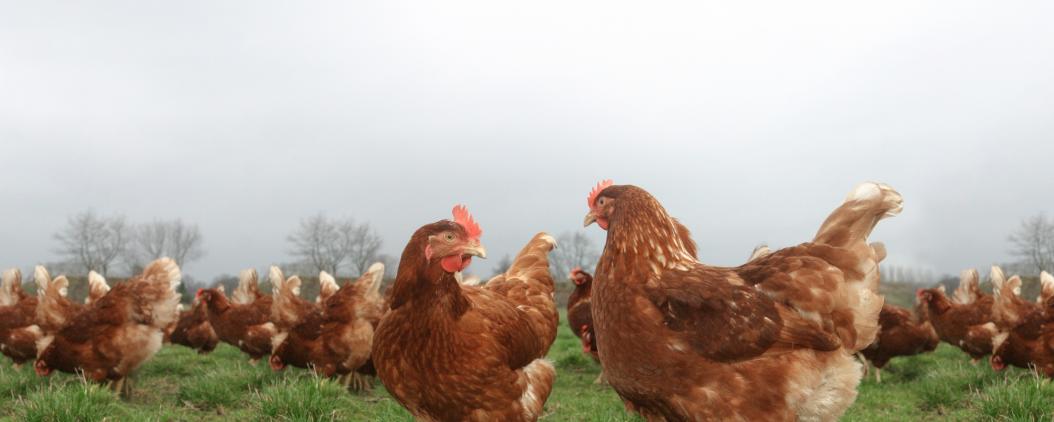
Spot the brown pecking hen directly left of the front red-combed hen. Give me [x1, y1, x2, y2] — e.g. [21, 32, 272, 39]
[270, 263, 385, 388]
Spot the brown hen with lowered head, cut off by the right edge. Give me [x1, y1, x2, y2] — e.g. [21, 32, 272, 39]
[990, 267, 1054, 378]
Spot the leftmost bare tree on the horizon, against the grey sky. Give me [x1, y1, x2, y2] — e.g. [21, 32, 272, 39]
[54, 211, 130, 275]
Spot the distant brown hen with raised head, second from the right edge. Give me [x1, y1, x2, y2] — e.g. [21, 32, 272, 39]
[915, 271, 996, 362]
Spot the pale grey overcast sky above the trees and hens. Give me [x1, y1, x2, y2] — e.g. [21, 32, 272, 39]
[0, 0, 1054, 280]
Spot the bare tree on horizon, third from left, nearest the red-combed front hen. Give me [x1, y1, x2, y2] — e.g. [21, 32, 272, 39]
[287, 213, 382, 276]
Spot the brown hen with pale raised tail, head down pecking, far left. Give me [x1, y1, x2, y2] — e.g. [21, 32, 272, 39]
[34, 258, 181, 392]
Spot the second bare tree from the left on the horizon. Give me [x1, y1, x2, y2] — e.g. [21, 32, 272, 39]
[124, 219, 204, 273]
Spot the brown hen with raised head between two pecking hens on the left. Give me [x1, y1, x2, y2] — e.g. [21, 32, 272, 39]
[195, 271, 276, 364]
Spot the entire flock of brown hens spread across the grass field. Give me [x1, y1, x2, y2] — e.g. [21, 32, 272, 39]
[0, 180, 1054, 421]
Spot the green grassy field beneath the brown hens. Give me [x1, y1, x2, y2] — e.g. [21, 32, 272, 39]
[0, 318, 1054, 421]
